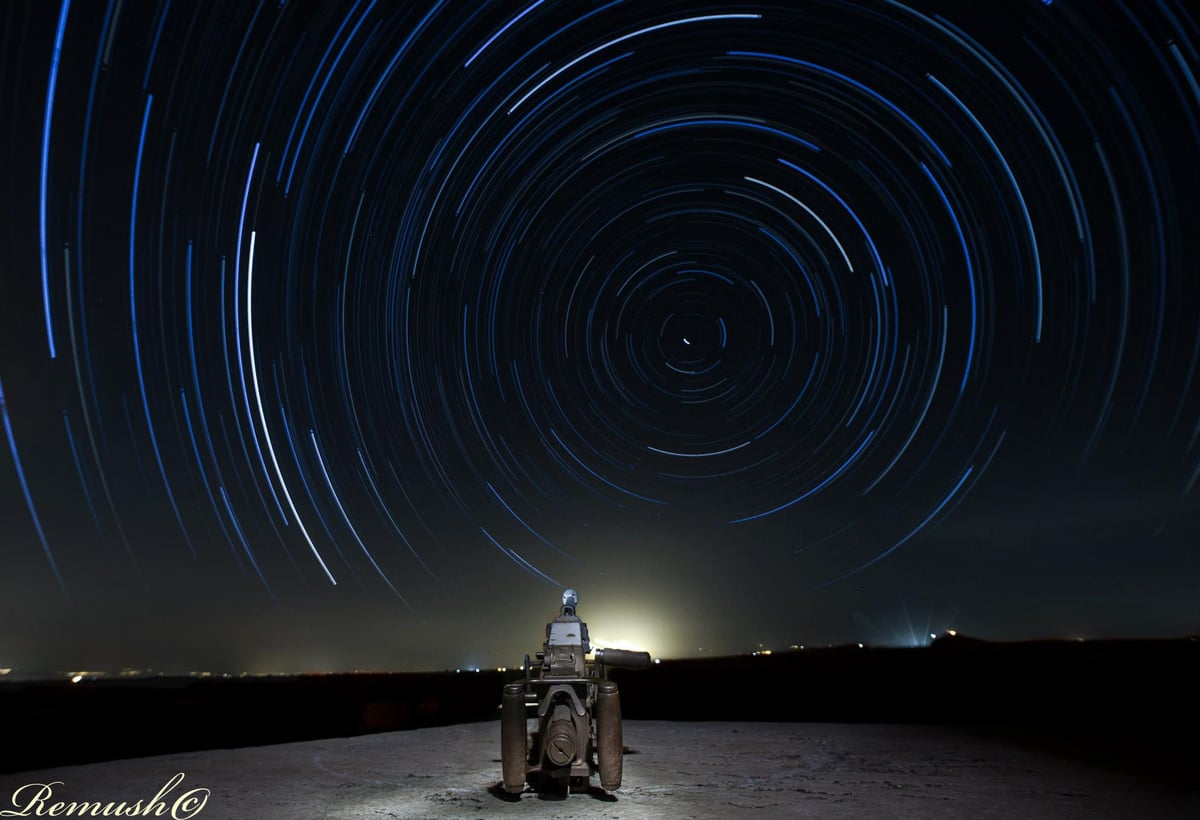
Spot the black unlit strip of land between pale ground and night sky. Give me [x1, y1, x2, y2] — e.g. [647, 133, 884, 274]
[0, 636, 1200, 785]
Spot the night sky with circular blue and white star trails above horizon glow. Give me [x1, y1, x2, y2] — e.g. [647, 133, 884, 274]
[0, 0, 1200, 676]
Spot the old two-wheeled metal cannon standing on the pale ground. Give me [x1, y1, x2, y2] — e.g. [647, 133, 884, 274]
[500, 589, 650, 795]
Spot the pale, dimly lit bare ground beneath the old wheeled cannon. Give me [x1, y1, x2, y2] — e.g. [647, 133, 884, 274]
[0, 720, 1200, 820]
